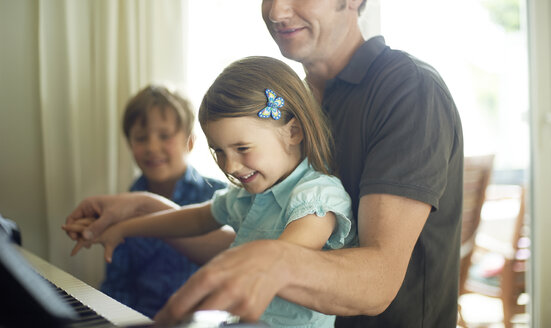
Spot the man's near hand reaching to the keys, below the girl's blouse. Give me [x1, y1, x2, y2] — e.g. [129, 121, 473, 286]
[155, 240, 291, 326]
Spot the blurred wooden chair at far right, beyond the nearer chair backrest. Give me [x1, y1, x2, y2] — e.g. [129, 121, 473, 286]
[461, 185, 530, 328]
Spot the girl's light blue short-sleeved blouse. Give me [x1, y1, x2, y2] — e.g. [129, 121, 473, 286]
[212, 159, 357, 327]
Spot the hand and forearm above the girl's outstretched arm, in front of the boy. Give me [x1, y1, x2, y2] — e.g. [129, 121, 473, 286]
[64, 192, 179, 241]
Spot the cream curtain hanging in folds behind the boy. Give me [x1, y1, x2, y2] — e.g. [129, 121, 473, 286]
[39, 0, 186, 286]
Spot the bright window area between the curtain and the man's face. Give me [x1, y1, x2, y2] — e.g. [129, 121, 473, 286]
[184, 0, 304, 180]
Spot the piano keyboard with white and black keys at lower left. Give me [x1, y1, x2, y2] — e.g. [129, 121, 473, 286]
[18, 247, 153, 328]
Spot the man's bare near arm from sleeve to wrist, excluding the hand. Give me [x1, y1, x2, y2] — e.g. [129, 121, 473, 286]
[278, 194, 431, 315]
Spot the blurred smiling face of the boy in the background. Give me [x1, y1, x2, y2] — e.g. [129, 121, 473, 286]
[128, 108, 192, 183]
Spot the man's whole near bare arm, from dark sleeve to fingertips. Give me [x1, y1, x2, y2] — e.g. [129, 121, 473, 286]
[155, 194, 431, 323]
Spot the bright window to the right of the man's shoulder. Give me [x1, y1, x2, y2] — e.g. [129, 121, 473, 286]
[381, 0, 530, 183]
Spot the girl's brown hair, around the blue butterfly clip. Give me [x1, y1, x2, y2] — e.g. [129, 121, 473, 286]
[199, 56, 334, 174]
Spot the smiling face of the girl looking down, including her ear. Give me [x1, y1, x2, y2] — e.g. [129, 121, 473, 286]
[203, 116, 302, 194]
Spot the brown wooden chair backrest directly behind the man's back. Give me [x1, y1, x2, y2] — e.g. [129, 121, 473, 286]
[459, 154, 494, 294]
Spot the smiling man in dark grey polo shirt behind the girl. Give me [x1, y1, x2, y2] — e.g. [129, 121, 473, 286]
[64, 0, 463, 327]
